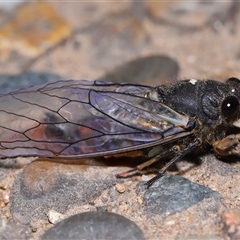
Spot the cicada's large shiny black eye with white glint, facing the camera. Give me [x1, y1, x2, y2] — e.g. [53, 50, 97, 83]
[222, 96, 239, 118]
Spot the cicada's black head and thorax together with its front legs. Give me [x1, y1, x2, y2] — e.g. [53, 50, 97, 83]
[143, 78, 240, 185]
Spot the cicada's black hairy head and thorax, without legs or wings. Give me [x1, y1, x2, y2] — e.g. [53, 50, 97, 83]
[154, 78, 240, 142]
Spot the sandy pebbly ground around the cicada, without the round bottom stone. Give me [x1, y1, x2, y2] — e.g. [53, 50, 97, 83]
[0, 1, 240, 239]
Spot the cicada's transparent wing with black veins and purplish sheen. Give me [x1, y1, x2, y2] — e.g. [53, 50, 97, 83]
[0, 81, 191, 158]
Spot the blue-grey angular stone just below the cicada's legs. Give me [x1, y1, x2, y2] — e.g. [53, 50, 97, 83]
[143, 175, 221, 215]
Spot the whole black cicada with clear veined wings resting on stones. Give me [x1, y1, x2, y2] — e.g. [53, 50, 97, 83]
[0, 78, 240, 186]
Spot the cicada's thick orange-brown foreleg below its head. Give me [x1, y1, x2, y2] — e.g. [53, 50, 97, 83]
[213, 134, 240, 156]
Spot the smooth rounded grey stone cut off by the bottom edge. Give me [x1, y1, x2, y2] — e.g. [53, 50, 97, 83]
[40, 212, 145, 240]
